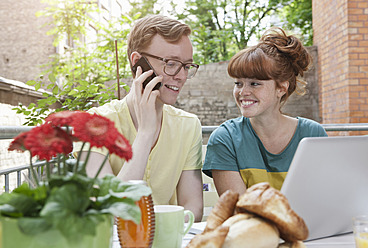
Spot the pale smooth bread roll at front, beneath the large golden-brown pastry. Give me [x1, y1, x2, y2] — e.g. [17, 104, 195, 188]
[222, 213, 280, 248]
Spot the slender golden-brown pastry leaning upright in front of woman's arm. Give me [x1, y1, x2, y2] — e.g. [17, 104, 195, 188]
[204, 190, 239, 232]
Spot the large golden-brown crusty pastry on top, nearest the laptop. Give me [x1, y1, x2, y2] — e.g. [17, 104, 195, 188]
[236, 182, 308, 242]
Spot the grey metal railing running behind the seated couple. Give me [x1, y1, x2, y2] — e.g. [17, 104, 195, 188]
[0, 123, 368, 192]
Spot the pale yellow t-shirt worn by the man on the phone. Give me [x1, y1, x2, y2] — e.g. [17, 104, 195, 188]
[74, 98, 202, 205]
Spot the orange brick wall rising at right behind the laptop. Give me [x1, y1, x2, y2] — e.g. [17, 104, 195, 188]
[313, 0, 368, 126]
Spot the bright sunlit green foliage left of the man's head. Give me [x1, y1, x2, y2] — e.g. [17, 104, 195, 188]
[14, 0, 153, 126]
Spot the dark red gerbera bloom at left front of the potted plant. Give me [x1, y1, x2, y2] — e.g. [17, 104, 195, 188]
[24, 123, 73, 160]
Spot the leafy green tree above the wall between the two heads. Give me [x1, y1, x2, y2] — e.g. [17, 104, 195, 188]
[173, 0, 289, 64]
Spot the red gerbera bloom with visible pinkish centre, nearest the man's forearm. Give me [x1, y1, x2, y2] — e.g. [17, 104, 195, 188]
[73, 114, 118, 147]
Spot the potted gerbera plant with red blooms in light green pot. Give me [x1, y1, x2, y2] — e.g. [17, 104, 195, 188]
[0, 111, 151, 248]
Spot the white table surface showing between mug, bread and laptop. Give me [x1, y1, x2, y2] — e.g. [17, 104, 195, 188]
[112, 222, 355, 248]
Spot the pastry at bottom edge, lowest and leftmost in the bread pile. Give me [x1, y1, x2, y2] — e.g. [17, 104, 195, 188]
[186, 226, 229, 248]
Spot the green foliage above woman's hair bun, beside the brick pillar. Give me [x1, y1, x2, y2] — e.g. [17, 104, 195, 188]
[280, 0, 313, 46]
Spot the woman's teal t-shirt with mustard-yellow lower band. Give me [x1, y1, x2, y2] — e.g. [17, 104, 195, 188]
[203, 117, 327, 189]
